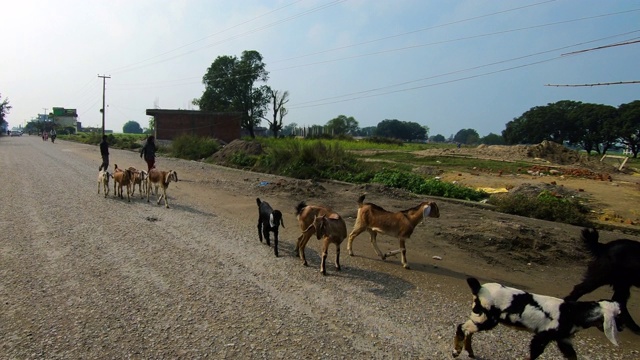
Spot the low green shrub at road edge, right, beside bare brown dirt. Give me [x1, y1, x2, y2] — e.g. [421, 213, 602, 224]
[489, 191, 590, 226]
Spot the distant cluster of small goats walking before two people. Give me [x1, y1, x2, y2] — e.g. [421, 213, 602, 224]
[98, 164, 178, 208]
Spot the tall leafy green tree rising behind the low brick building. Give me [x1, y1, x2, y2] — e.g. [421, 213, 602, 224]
[199, 50, 269, 138]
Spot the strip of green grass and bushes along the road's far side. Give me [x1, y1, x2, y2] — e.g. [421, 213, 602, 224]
[61, 133, 640, 226]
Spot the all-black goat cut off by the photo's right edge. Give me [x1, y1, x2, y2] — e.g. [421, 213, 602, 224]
[564, 228, 640, 335]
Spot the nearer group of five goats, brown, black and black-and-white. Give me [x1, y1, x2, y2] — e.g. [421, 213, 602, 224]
[256, 195, 640, 359]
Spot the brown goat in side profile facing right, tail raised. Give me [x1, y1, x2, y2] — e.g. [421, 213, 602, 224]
[347, 195, 440, 269]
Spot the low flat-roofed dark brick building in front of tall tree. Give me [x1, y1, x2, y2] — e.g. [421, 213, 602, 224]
[147, 109, 242, 143]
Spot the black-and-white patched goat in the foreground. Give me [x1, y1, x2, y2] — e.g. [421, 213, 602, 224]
[453, 278, 620, 360]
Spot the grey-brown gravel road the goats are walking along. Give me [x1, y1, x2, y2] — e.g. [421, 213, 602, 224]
[0, 136, 639, 359]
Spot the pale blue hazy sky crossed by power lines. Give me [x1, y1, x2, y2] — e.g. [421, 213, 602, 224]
[0, 0, 640, 137]
